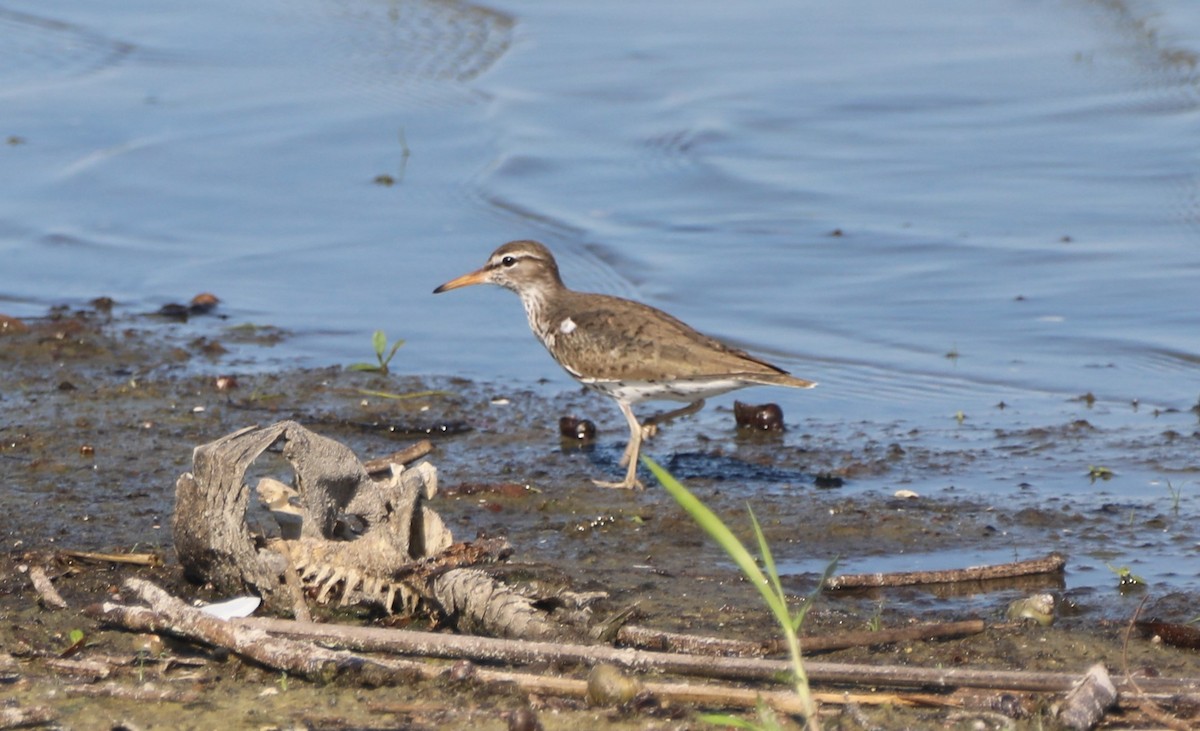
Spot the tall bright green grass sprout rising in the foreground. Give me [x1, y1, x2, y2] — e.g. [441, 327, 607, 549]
[642, 456, 838, 731]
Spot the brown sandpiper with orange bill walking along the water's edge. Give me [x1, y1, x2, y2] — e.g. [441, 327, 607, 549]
[433, 240, 816, 490]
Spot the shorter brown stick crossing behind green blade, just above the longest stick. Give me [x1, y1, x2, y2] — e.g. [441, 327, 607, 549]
[617, 619, 984, 657]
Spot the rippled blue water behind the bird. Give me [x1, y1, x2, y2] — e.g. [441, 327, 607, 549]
[0, 0, 1200, 580]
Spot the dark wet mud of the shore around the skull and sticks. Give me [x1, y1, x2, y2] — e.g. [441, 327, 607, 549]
[0, 301, 1200, 729]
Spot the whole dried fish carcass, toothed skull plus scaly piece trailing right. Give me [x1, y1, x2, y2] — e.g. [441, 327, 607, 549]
[173, 421, 574, 639]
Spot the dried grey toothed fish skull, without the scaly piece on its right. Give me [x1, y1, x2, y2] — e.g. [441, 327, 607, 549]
[173, 421, 451, 611]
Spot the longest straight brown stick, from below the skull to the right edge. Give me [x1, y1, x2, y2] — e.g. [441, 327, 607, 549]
[236, 618, 1200, 702]
